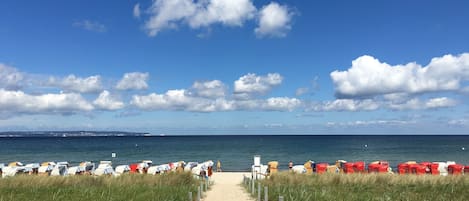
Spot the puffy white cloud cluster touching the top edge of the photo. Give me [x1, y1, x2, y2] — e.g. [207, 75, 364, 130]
[141, 0, 292, 37]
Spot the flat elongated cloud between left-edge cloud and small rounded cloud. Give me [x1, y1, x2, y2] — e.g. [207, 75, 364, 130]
[47, 75, 102, 93]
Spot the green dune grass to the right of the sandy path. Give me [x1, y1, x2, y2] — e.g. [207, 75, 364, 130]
[245, 173, 469, 201]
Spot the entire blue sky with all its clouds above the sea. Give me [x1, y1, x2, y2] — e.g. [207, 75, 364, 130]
[0, 0, 469, 135]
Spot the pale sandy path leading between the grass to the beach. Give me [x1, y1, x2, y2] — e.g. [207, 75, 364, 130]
[203, 172, 253, 201]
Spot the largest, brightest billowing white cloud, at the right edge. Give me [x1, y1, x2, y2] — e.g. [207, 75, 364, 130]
[330, 53, 469, 98]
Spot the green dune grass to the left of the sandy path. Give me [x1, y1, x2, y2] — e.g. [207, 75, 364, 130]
[0, 173, 199, 201]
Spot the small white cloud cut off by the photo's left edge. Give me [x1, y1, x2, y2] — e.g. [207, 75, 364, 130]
[0, 63, 24, 90]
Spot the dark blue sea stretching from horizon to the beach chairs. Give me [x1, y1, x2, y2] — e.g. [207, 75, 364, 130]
[0, 135, 469, 171]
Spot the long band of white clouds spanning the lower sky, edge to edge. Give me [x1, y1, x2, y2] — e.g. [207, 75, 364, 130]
[0, 53, 469, 118]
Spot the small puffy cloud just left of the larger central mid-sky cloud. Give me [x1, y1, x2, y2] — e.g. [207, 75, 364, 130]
[192, 80, 226, 98]
